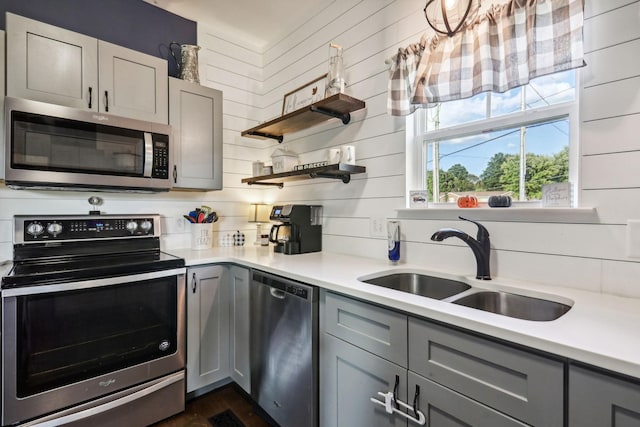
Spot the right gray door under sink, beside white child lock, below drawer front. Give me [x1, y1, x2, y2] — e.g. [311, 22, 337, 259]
[407, 371, 528, 427]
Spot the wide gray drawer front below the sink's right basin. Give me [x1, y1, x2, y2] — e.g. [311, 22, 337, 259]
[409, 317, 565, 427]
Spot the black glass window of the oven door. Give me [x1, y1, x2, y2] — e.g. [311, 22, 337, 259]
[17, 277, 177, 397]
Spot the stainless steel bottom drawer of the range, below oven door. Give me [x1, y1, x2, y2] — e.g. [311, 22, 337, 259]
[22, 371, 185, 427]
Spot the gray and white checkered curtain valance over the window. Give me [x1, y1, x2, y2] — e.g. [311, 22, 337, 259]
[387, 0, 584, 116]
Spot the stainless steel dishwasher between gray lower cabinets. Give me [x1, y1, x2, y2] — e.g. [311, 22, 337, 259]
[250, 271, 318, 427]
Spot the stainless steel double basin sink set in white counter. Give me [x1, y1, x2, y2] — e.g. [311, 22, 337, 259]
[359, 272, 571, 321]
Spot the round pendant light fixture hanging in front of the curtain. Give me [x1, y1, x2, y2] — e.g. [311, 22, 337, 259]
[424, 0, 480, 37]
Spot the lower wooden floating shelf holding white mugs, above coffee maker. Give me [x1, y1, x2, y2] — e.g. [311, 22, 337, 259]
[242, 163, 367, 188]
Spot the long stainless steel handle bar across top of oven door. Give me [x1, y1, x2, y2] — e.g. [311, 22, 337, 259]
[2, 267, 187, 298]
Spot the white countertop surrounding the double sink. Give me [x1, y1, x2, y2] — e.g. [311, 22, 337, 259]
[168, 246, 640, 378]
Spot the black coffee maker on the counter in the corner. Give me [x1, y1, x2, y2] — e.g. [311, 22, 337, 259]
[269, 205, 322, 255]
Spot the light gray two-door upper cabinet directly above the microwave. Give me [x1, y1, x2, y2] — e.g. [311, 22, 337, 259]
[7, 13, 168, 124]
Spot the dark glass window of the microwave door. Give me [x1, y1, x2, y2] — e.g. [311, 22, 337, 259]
[12, 115, 144, 176]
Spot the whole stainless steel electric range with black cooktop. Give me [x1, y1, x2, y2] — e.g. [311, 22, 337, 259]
[1, 215, 186, 427]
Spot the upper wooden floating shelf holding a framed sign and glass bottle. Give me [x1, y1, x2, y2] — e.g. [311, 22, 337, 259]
[242, 93, 365, 142]
